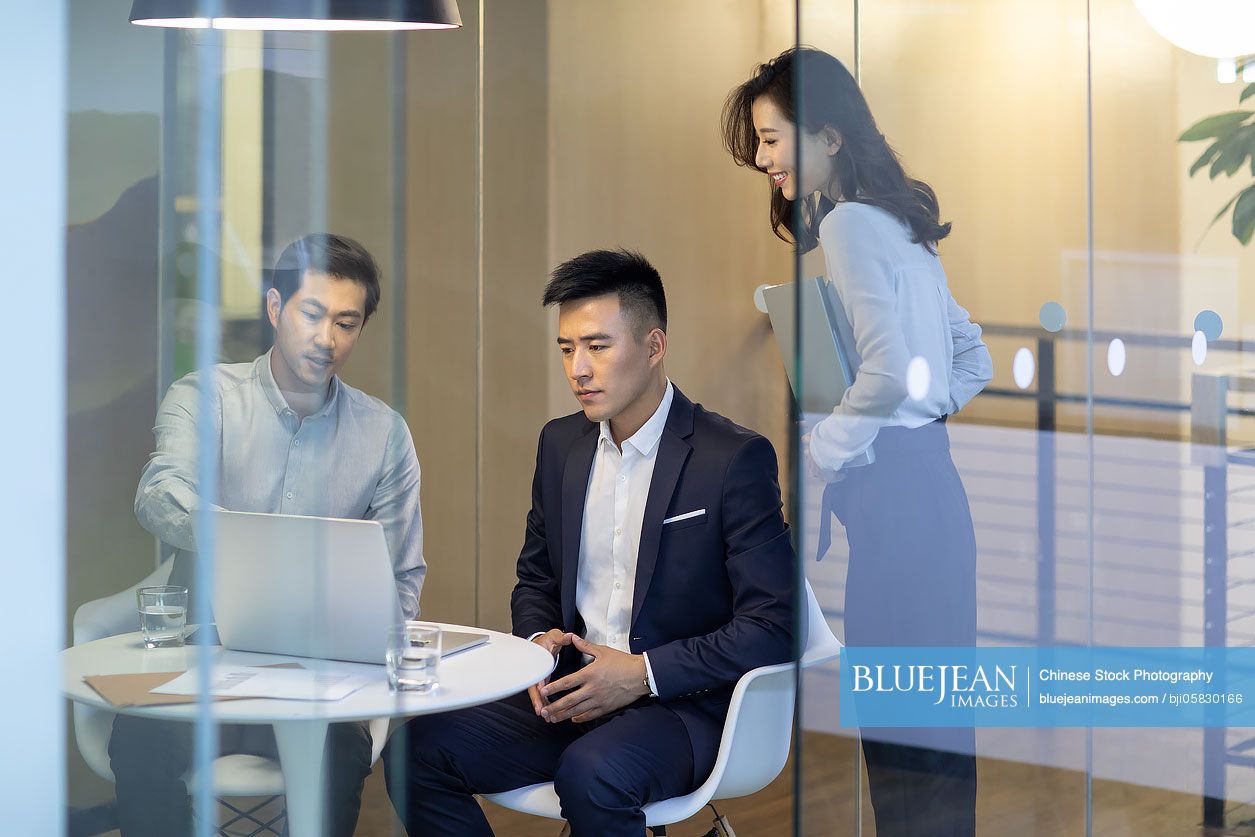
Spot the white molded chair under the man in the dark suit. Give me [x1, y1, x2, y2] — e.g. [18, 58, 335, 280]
[483, 581, 841, 834]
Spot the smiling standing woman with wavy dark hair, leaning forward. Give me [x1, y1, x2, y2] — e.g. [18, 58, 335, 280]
[723, 48, 993, 837]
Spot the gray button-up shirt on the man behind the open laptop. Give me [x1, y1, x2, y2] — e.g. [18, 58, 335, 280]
[136, 351, 427, 619]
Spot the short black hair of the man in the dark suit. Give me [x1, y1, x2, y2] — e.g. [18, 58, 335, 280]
[542, 250, 666, 339]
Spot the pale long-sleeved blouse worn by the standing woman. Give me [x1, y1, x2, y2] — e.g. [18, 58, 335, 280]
[811, 202, 994, 471]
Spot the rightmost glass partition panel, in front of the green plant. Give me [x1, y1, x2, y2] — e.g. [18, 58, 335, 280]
[1089, 1, 1255, 832]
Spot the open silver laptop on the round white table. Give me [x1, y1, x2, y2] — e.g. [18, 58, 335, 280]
[213, 511, 488, 664]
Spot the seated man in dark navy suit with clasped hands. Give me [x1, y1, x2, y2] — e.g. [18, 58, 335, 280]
[385, 251, 794, 837]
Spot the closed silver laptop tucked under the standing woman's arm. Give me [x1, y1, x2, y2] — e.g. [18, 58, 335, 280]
[762, 276, 876, 468]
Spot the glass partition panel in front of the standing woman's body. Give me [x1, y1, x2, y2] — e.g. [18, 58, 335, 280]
[797, 1, 1102, 834]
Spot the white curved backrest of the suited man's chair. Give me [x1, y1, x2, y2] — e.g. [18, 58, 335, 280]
[703, 580, 841, 799]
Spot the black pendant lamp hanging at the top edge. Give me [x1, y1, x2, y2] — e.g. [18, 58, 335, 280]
[131, 0, 462, 31]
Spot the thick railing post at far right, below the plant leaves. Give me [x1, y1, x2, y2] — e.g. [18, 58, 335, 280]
[1190, 374, 1229, 828]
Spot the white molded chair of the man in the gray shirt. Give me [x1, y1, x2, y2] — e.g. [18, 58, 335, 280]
[74, 560, 388, 834]
